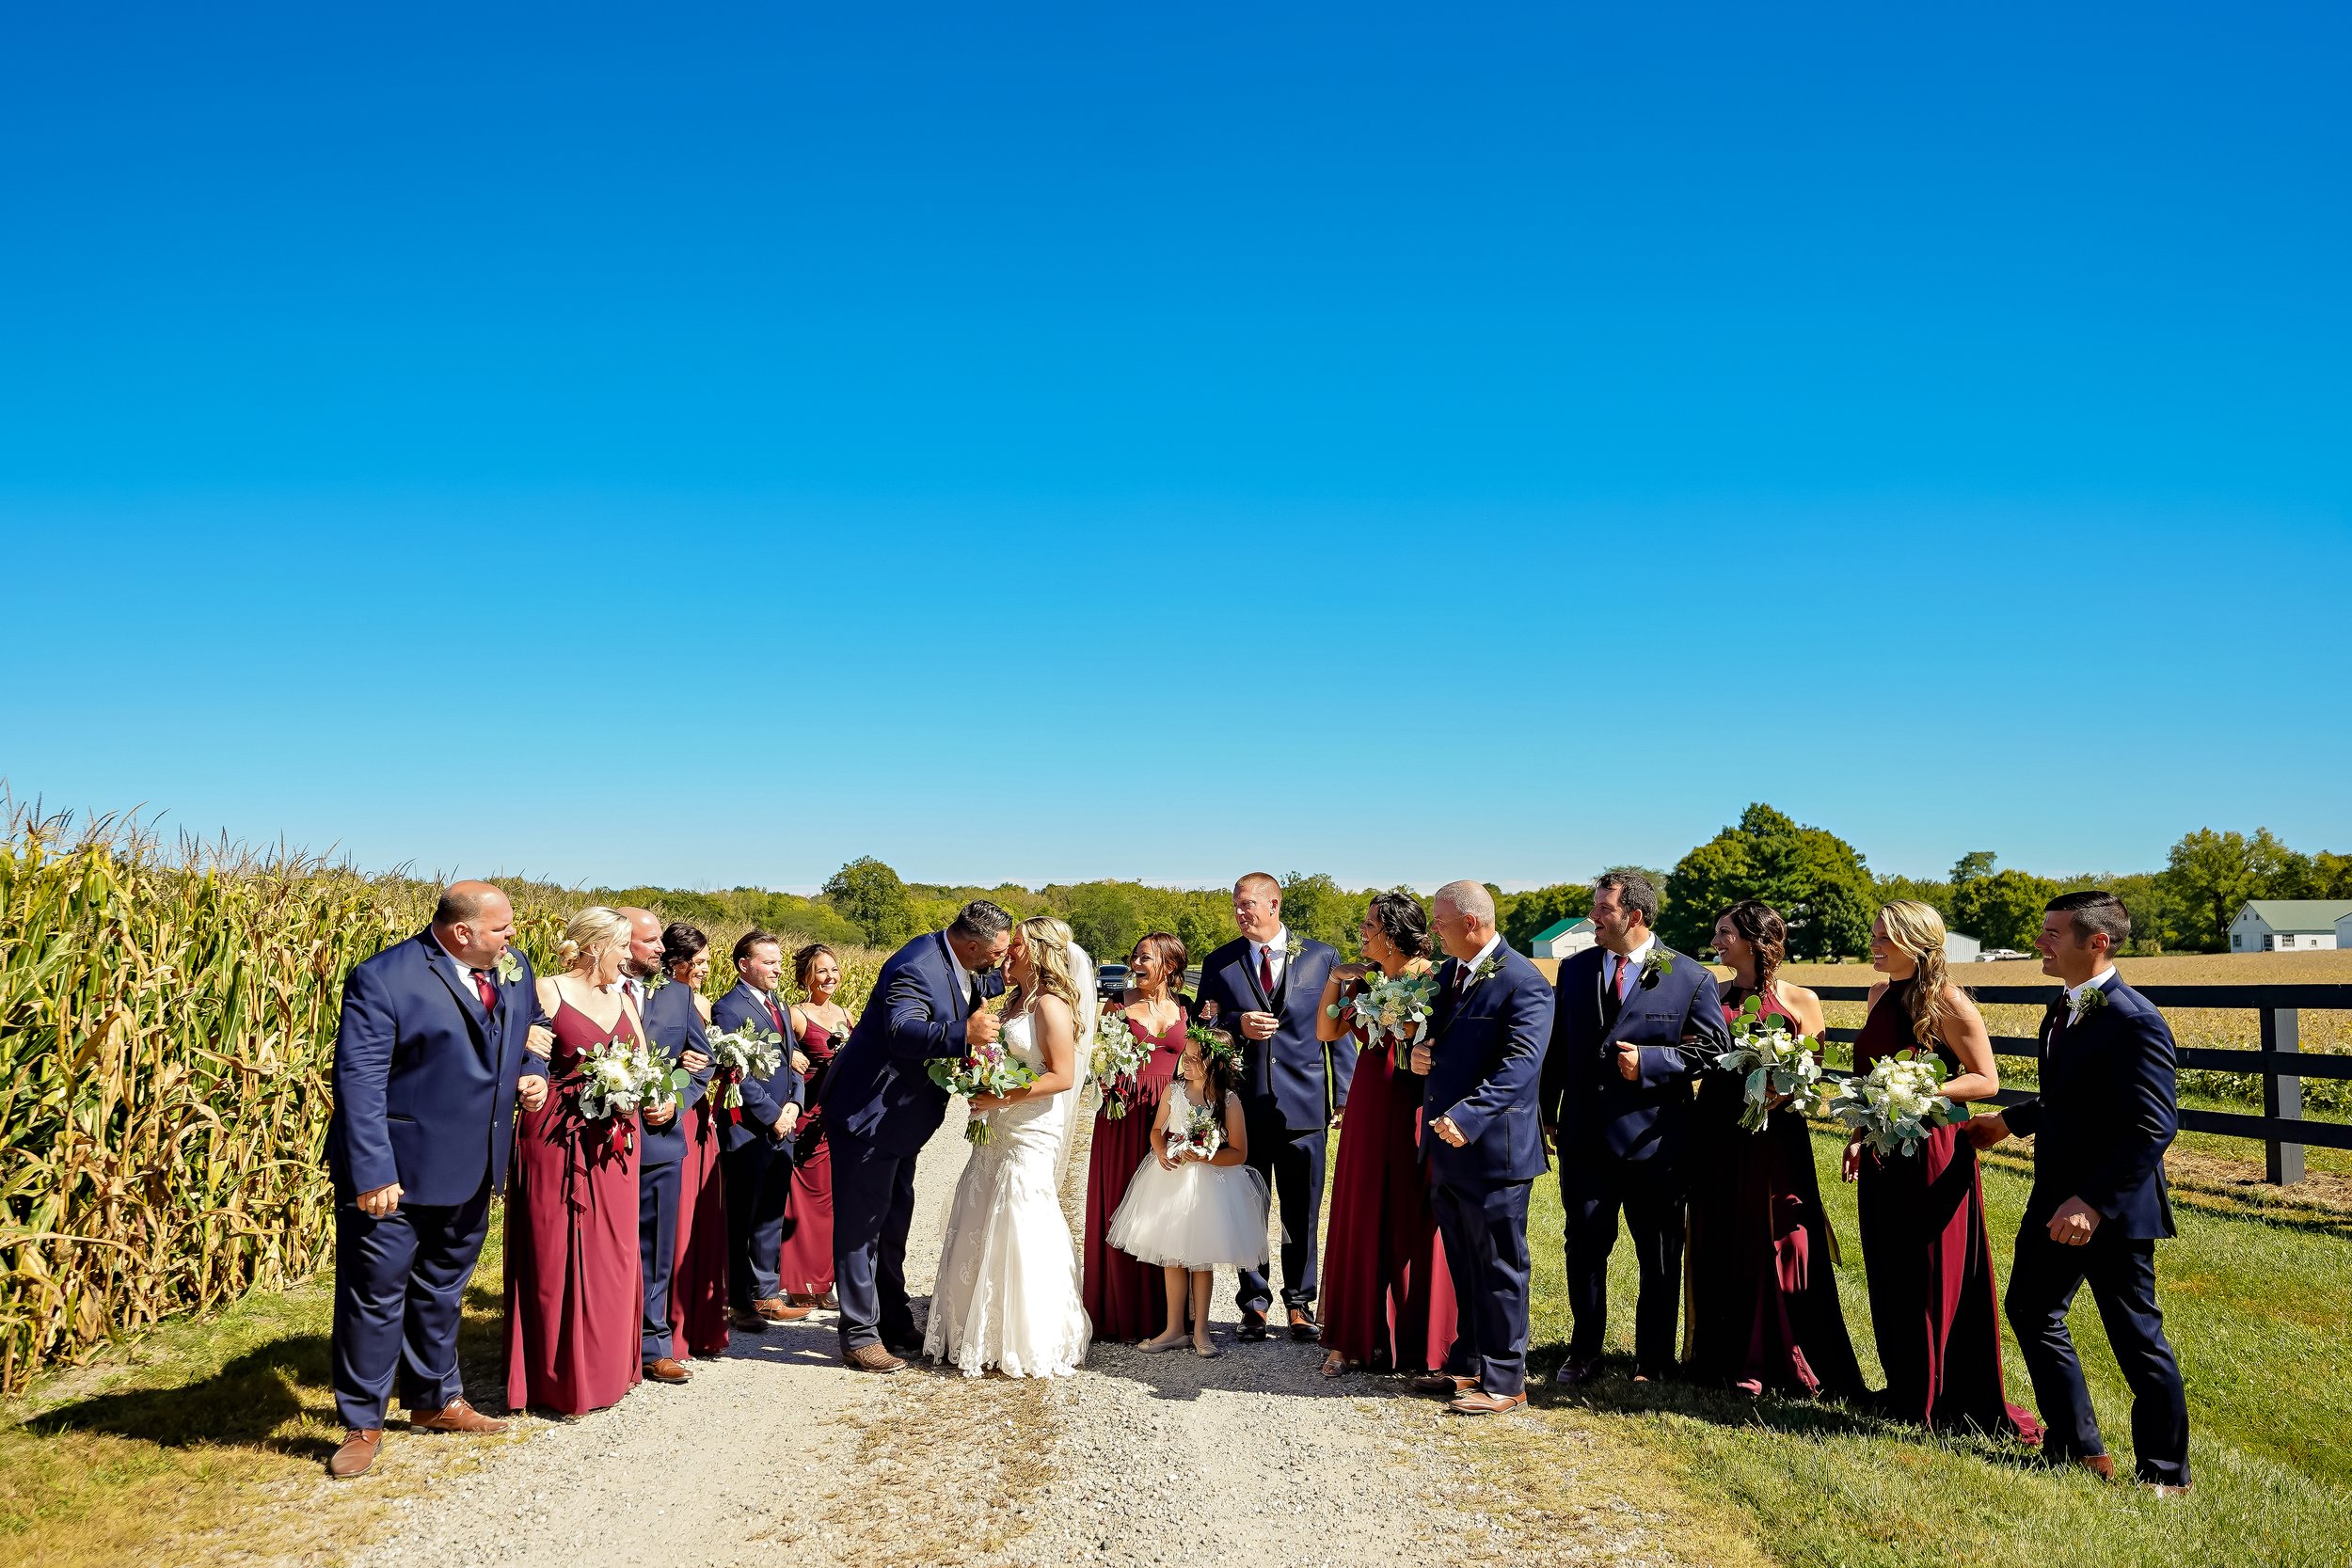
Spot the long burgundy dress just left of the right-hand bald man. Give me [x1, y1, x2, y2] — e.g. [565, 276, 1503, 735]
[1322, 983, 1456, 1373]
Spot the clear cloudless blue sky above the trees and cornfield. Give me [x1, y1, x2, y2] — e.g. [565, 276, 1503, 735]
[0, 5, 2352, 886]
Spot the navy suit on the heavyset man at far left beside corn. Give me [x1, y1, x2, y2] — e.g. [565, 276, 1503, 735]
[327, 928, 546, 1432]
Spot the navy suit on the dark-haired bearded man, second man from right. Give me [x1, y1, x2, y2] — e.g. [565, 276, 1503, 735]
[1543, 942, 1731, 1373]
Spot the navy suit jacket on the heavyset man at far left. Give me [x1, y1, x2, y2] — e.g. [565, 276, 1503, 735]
[327, 927, 548, 1206]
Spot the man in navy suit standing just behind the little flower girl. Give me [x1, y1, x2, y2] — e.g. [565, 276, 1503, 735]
[1195, 872, 1355, 1340]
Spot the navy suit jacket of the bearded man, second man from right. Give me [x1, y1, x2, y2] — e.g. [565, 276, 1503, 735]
[1543, 942, 1731, 1164]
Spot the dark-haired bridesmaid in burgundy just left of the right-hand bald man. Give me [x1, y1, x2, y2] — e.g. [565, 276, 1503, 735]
[1315, 894, 1456, 1378]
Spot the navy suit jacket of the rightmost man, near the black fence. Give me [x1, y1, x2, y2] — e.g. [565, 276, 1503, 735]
[2002, 975, 2181, 1242]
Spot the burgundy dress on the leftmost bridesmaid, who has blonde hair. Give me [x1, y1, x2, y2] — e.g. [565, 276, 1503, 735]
[506, 1002, 644, 1416]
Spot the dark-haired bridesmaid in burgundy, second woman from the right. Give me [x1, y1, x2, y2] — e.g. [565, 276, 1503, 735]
[1684, 898, 1863, 1399]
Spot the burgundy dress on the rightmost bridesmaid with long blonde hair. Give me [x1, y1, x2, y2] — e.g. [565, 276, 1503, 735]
[1853, 980, 2042, 1444]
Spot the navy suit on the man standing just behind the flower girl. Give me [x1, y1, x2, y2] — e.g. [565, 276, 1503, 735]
[1193, 938, 1355, 1317]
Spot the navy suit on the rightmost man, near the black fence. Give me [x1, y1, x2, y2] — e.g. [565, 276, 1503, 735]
[2002, 975, 2190, 1486]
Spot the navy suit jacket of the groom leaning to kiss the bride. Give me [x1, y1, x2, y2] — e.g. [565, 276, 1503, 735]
[826, 931, 1005, 1154]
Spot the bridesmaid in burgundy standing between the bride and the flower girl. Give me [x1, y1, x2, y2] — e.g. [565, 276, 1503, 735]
[1080, 931, 1185, 1342]
